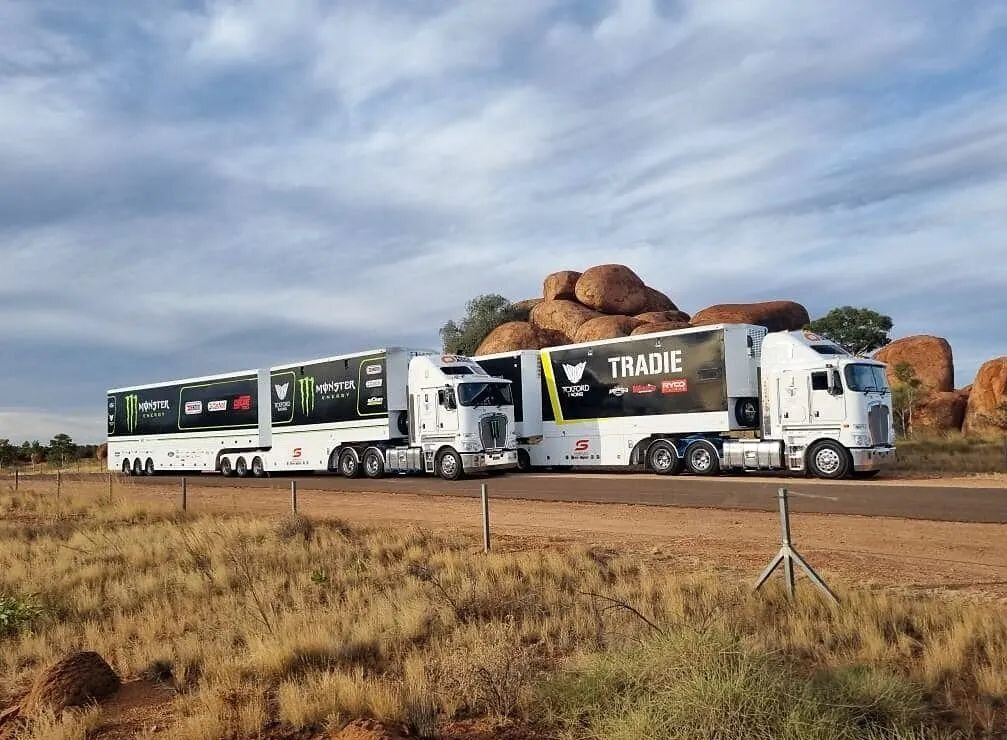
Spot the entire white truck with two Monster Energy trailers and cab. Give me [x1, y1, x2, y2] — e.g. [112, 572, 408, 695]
[108, 347, 518, 480]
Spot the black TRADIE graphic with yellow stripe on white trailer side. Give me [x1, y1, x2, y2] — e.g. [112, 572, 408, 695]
[542, 329, 727, 424]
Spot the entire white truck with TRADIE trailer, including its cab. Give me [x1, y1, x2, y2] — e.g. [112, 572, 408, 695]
[475, 324, 894, 478]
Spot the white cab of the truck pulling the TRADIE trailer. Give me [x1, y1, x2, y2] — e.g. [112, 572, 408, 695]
[760, 331, 895, 478]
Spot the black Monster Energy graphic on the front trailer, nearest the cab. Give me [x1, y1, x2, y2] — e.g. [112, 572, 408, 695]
[270, 353, 388, 427]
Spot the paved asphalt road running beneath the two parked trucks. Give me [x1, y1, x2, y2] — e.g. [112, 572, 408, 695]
[119, 473, 1007, 524]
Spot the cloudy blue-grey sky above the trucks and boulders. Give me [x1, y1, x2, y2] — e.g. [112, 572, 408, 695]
[0, 0, 1007, 442]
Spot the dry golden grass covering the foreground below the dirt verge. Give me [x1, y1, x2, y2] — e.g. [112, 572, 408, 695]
[0, 490, 1007, 740]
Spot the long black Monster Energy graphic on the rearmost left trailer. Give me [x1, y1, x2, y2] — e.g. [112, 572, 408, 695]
[108, 375, 259, 437]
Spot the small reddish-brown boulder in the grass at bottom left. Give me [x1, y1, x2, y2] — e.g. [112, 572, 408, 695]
[21, 652, 122, 717]
